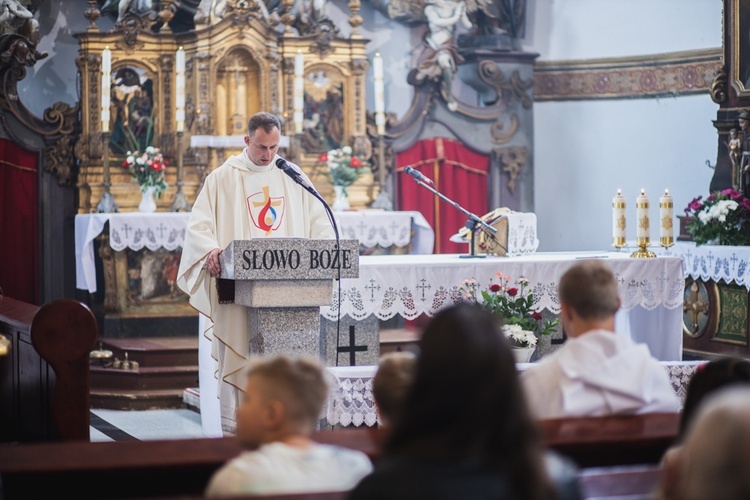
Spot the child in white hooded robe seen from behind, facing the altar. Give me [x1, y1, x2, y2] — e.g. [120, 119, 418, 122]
[521, 260, 680, 419]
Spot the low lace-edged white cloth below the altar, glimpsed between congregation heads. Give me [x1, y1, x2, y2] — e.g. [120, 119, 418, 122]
[326, 361, 705, 427]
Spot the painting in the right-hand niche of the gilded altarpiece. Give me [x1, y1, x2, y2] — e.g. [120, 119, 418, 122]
[301, 65, 345, 155]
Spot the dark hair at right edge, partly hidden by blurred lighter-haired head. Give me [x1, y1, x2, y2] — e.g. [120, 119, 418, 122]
[680, 357, 750, 440]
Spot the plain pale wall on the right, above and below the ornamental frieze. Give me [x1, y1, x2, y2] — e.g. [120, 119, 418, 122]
[524, 0, 722, 251]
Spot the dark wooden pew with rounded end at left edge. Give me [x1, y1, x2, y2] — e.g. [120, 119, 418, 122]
[0, 296, 97, 442]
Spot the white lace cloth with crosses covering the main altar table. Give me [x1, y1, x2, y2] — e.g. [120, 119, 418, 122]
[321, 252, 685, 361]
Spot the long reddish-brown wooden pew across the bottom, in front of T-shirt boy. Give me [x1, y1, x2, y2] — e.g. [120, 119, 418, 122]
[0, 414, 679, 500]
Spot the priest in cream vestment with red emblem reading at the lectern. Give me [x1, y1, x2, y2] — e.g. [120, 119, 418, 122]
[177, 112, 334, 434]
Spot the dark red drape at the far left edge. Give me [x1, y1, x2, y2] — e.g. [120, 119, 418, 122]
[0, 139, 40, 305]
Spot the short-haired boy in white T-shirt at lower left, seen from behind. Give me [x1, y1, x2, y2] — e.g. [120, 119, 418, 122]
[206, 356, 372, 497]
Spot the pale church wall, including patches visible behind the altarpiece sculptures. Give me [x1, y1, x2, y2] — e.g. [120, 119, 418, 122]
[13, 0, 722, 251]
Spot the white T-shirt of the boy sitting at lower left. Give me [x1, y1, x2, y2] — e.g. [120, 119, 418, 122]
[206, 443, 372, 497]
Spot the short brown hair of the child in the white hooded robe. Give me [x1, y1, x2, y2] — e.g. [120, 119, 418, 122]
[560, 259, 620, 320]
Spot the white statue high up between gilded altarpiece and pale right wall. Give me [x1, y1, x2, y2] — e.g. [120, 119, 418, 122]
[416, 0, 472, 111]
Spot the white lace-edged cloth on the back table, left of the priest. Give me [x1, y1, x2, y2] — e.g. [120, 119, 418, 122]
[75, 212, 190, 293]
